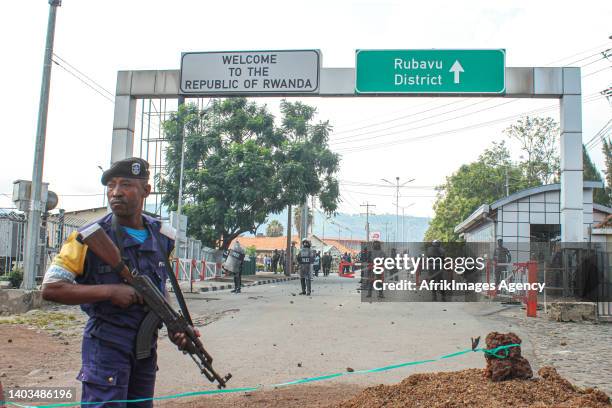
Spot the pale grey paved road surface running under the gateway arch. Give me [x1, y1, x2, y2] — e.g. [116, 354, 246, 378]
[157, 275, 529, 395]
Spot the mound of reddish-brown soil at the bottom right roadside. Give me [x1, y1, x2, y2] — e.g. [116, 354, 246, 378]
[334, 367, 610, 408]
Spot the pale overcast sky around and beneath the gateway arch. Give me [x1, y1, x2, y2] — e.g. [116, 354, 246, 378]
[0, 0, 612, 220]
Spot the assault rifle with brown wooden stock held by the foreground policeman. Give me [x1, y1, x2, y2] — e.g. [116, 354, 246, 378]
[79, 223, 232, 388]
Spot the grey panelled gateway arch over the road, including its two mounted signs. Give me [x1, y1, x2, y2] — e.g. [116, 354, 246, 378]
[111, 50, 588, 242]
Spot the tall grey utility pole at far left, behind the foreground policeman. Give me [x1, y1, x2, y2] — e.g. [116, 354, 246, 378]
[23, 0, 62, 289]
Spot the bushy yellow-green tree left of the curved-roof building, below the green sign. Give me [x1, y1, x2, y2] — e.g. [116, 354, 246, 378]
[425, 142, 528, 242]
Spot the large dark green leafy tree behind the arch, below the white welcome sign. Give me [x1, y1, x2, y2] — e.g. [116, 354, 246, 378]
[159, 98, 339, 249]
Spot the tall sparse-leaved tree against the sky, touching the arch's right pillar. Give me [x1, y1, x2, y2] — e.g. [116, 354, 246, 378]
[504, 116, 559, 187]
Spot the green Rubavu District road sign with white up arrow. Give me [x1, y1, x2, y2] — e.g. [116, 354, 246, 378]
[355, 50, 506, 94]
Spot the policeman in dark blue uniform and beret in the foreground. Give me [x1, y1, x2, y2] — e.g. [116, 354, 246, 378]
[42, 158, 199, 407]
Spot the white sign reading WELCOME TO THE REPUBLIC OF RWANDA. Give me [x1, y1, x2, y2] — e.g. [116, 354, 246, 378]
[180, 50, 321, 95]
